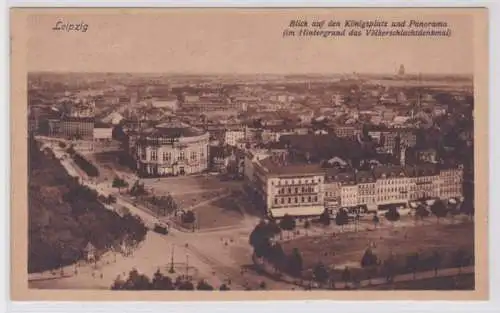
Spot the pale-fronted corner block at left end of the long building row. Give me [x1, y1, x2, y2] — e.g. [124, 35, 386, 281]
[254, 157, 325, 218]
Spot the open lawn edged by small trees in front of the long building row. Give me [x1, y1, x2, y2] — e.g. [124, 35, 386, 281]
[282, 222, 474, 281]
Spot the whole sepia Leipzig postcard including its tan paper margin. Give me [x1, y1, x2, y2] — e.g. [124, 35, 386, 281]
[11, 8, 488, 300]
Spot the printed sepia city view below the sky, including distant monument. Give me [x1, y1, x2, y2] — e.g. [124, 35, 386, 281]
[27, 68, 475, 291]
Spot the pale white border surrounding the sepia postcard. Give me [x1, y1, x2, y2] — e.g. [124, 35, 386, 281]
[0, 0, 500, 313]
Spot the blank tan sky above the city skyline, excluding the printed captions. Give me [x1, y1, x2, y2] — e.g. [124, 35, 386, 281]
[27, 9, 474, 74]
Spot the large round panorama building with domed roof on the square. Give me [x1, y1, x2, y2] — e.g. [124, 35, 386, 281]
[134, 122, 209, 176]
